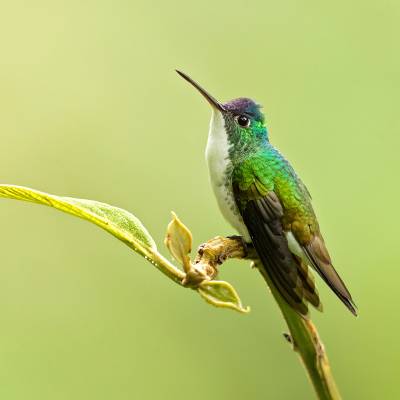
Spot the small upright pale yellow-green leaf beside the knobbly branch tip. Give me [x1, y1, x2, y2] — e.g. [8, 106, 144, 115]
[164, 212, 193, 273]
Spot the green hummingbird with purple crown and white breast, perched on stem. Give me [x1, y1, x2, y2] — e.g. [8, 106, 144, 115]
[176, 70, 357, 317]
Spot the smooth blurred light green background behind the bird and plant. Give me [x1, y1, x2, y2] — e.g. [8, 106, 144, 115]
[0, 0, 400, 400]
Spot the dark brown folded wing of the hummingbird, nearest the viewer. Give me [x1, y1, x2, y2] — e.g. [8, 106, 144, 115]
[233, 183, 320, 315]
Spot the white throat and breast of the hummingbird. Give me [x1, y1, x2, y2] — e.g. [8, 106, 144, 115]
[206, 111, 250, 241]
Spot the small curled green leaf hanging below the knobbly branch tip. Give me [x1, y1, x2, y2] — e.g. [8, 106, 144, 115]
[197, 281, 250, 313]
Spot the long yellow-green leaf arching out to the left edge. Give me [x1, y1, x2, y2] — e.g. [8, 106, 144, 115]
[0, 185, 157, 256]
